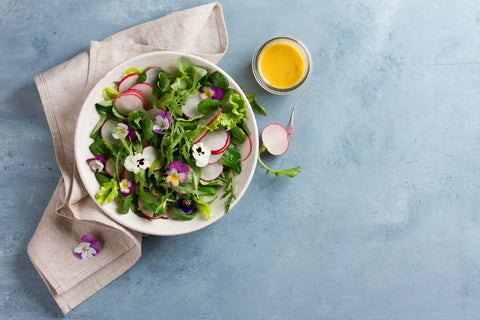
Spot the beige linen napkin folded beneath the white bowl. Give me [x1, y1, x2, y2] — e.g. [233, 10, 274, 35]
[28, 3, 228, 314]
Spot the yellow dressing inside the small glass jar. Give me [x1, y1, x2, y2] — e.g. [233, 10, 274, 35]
[259, 43, 305, 89]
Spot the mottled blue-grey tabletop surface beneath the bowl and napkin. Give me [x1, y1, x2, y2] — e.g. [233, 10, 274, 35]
[0, 0, 480, 319]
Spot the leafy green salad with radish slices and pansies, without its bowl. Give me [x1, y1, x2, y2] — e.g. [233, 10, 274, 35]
[87, 59, 261, 220]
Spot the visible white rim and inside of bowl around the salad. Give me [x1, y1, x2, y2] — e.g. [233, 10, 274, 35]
[75, 51, 258, 236]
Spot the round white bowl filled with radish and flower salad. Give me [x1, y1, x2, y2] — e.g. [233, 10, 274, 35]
[75, 52, 258, 235]
